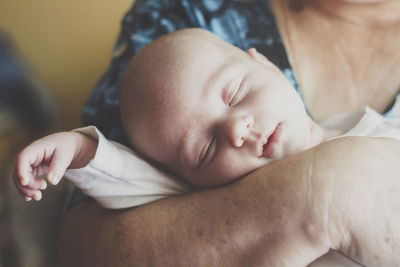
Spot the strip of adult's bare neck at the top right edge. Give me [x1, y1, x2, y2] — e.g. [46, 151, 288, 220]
[306, 0, 400, 27]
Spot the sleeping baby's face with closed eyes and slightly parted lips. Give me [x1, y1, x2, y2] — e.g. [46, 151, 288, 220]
[124, 29, 311, 187]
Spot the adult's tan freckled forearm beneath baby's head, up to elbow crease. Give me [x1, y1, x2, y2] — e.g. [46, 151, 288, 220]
[60, 146, 330, 266]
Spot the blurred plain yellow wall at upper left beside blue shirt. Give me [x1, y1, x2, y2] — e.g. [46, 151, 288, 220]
[0, 0, 133, 129]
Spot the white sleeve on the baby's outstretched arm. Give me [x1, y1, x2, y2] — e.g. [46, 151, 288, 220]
[64, 126, 191, 209]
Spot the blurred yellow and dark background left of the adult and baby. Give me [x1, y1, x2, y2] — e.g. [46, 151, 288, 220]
[0, 0, 134, 267]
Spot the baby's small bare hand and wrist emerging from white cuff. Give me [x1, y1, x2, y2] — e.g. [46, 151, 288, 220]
[13, 132, 97, 201]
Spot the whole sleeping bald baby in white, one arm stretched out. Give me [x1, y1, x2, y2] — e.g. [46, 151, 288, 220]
[13, 29, 400, 208]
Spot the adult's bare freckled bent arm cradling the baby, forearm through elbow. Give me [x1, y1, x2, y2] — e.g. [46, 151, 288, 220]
[59, 138, 400, 266]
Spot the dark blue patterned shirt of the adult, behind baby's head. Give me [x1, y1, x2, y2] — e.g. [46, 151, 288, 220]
[82, 0, 394, 144]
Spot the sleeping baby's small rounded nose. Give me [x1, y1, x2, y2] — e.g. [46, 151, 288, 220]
[226, 115, 254, 147]
